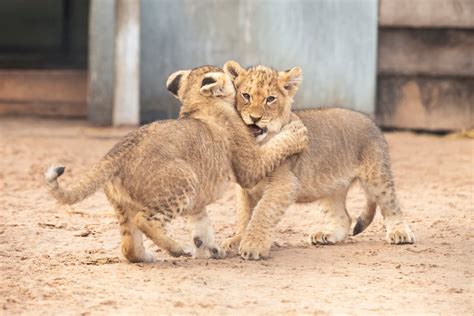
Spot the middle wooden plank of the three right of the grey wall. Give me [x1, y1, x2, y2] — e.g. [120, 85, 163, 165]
[378, 29, 474, 76]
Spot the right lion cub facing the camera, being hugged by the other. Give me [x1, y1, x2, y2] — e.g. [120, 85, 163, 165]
[223, 61, 415, 260]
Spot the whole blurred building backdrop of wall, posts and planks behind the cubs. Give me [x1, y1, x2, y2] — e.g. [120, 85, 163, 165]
[0, 0, 474, 131]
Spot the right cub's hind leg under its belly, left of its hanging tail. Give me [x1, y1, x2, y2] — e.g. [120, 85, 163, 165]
[309, 189, 352, 245]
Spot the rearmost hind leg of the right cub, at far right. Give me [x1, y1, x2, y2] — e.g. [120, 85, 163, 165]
[365, 163, 415, 244]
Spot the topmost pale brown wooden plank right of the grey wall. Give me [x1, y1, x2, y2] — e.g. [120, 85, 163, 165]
[379, 0, 474, 28]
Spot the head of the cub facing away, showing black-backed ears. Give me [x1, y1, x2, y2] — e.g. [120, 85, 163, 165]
[166, 66, 235, 117]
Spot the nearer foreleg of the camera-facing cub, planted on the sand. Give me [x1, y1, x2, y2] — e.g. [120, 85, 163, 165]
[239, 162, 298, 260]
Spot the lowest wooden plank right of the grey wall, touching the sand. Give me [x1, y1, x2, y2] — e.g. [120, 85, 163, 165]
[376, 76, 474, 130]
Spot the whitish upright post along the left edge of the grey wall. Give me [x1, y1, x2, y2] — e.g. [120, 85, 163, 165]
[113, 0, 140, 126]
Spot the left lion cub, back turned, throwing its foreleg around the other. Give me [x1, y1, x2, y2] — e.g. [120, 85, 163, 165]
[45, 66, 308, 262]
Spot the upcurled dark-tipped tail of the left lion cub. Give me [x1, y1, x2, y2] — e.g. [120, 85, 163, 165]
[44, 157, 118, 205]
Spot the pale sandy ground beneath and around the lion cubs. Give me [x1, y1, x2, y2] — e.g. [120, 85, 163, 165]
[0, 118, 474, 315]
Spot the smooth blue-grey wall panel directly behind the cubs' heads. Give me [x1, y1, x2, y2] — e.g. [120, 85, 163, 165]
[140, 0, 377, 121]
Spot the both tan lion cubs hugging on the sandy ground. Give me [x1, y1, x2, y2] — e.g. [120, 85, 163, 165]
[45, 61, 414, 262]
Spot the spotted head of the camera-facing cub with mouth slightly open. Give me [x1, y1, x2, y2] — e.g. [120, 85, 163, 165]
[224, 61, 303, 141]
